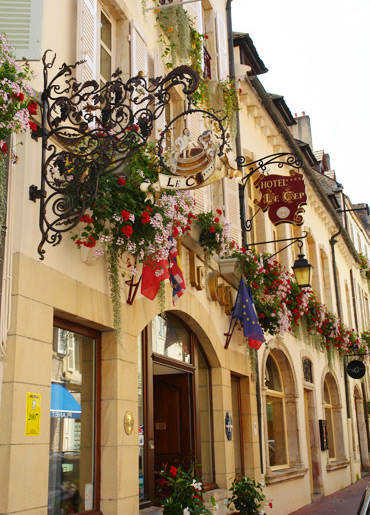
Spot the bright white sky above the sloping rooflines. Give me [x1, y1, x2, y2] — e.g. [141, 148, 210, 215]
[231, 0, 370, 204]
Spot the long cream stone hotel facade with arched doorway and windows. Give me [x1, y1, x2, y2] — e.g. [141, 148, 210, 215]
[0, 0, 370, 515]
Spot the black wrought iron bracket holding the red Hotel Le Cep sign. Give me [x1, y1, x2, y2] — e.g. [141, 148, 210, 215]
[236, 152, 302, 237]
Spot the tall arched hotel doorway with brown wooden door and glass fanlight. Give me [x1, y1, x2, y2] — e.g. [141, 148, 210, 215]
[138, 312, 215, 503]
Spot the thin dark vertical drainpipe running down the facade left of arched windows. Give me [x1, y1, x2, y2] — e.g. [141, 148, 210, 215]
[226, 0, 263, 474]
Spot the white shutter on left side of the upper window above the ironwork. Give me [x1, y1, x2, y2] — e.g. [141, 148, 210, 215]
[77, 0, 98, 82]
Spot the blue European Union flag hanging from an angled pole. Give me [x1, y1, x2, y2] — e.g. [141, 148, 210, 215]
[225, 278, 265, 350]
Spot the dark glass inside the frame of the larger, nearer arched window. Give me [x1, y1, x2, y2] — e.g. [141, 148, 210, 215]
[265, 355, 288, 467]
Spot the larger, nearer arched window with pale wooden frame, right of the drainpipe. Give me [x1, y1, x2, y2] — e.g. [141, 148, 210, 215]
[264, 350, 300, 470]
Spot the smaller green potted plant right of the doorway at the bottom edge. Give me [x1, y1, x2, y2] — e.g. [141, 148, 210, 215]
[227, 476, 271, 515]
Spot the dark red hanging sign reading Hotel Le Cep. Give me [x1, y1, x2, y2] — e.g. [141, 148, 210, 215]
[254, 170, 307, 225]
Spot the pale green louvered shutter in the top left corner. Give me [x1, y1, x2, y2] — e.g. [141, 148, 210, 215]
[0, 0, 43, 61]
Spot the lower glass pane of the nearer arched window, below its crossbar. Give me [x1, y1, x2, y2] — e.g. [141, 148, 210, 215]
[266, 395, 287, 467]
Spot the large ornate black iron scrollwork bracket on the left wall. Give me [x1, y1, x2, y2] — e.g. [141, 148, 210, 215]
[29, 50, 225, 259]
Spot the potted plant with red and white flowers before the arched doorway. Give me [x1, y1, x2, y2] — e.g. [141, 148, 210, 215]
[157, 464, 211, 515]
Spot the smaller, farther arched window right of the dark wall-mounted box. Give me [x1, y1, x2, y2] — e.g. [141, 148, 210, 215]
[323, 373, 344, 460]
